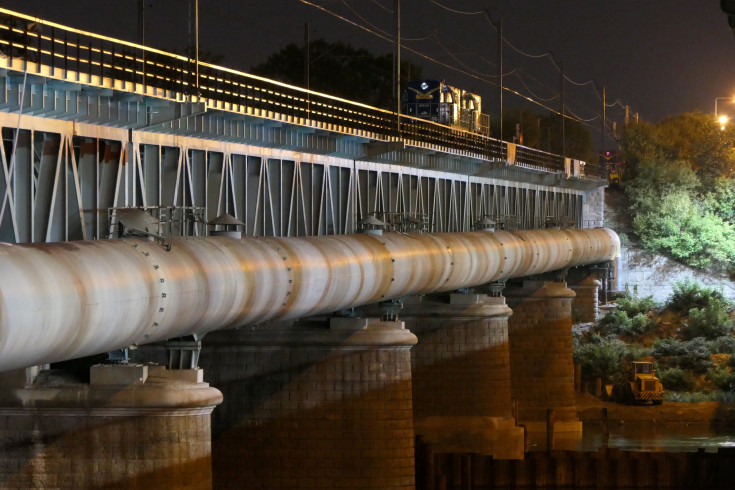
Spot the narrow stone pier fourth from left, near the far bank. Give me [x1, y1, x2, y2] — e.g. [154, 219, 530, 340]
[506, 281, 582, 434]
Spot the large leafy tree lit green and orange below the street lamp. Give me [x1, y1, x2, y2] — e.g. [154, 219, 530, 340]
[621, 113, 735, 272]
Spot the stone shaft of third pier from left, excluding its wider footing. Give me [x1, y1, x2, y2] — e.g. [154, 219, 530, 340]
[399, 295, 512, 419]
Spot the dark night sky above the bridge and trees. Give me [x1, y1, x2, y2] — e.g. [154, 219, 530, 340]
[0, 0, 735, 144]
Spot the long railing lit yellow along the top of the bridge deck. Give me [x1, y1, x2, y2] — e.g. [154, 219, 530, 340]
[0, 9, 601, 178]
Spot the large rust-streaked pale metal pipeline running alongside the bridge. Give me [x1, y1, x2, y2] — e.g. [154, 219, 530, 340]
[0, 228, 620, 371]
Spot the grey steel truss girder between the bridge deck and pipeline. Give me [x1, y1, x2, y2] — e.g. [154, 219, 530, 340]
[0, 109, 583, 242]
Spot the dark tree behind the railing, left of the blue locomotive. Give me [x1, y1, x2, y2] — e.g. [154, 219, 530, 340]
[251, 39, 422, 110]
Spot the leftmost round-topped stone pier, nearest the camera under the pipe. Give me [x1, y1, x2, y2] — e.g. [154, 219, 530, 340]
[0, 365, 222, 490]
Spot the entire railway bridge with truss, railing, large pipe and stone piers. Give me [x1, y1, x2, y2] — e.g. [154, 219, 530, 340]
[0, 9, 619, 488]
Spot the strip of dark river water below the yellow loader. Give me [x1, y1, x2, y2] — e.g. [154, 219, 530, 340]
[528, 424, 735, 452]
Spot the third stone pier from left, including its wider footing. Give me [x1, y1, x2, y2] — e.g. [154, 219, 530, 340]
[399, 293, 524, 459]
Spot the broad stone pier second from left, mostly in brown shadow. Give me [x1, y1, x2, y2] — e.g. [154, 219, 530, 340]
[200, 318, 416, 490]
